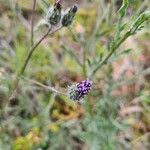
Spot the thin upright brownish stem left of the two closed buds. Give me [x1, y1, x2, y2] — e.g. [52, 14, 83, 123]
[31, 0, 36, 46]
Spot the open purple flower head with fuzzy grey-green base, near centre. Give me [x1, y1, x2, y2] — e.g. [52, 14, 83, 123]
[68, 79, 92, 101]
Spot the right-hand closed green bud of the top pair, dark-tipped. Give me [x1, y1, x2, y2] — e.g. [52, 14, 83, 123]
[62, 5, 78, 27]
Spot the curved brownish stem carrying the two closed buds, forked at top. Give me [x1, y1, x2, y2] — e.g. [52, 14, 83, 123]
[9, 27, 61, 99]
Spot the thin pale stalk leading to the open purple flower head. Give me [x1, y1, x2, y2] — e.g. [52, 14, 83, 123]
[23, 77, 67, 96]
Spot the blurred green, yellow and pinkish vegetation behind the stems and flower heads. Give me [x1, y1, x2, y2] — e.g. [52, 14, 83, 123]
[0, 0, 150, 150]
